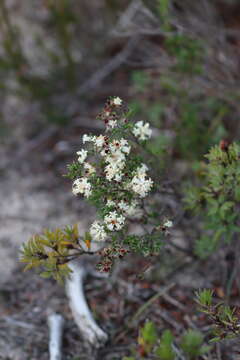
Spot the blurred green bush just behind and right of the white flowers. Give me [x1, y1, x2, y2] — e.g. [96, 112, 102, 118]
[131, 71, 230, 161]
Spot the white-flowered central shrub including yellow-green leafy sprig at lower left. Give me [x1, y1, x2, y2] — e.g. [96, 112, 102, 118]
[22, 97, 172, 280]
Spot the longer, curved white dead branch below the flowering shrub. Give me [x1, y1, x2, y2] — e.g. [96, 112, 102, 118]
[66, 263, 108, 347]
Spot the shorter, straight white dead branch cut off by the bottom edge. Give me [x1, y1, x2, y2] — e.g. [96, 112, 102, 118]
[48, 313, 64, 360]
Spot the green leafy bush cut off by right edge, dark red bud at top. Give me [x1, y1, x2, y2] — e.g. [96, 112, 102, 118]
[185, 141, 240, 258]
